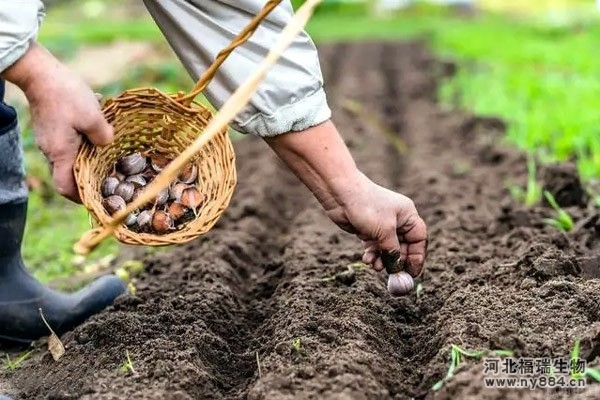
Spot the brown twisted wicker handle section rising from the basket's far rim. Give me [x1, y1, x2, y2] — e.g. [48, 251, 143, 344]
[177, 0, 281, 106]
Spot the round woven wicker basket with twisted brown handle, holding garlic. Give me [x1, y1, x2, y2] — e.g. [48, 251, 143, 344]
[74, 0, 281, 246]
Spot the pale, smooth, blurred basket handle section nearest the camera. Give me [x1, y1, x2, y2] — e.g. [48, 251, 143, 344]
[73, 0, 322, 254]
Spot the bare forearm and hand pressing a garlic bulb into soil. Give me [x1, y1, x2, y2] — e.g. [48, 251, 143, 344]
[265, 117, 427, 277]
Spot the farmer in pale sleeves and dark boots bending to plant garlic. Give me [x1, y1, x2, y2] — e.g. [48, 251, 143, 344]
[0, 0, 426, 356]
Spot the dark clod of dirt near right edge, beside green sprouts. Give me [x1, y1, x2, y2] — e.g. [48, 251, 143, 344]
[542, 163, 589, 207]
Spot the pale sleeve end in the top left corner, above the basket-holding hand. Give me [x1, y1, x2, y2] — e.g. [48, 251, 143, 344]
[0, 0, 45, 72]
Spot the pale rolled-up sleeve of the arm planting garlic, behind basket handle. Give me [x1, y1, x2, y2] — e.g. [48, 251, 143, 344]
[144, 0, 331, 137]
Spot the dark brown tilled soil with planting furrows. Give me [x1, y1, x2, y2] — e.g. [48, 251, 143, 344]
[0, 42, 600, 400]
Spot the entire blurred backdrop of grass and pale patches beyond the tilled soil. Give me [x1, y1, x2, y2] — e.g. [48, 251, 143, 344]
[9, 0, 600, 288]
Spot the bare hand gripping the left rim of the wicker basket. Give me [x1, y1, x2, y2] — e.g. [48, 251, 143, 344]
[2, 43, 113, 202]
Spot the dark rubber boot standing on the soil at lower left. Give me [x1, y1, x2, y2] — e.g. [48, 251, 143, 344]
[0, 200, 127, 343]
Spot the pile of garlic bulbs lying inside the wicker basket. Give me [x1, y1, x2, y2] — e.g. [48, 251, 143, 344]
[100, 152, 204, 234]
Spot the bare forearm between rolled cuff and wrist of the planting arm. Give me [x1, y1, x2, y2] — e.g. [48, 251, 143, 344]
[265, 121, 362, 210]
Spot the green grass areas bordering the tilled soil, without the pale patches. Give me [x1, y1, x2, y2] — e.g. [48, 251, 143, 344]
[22, 1, 600, 281]
